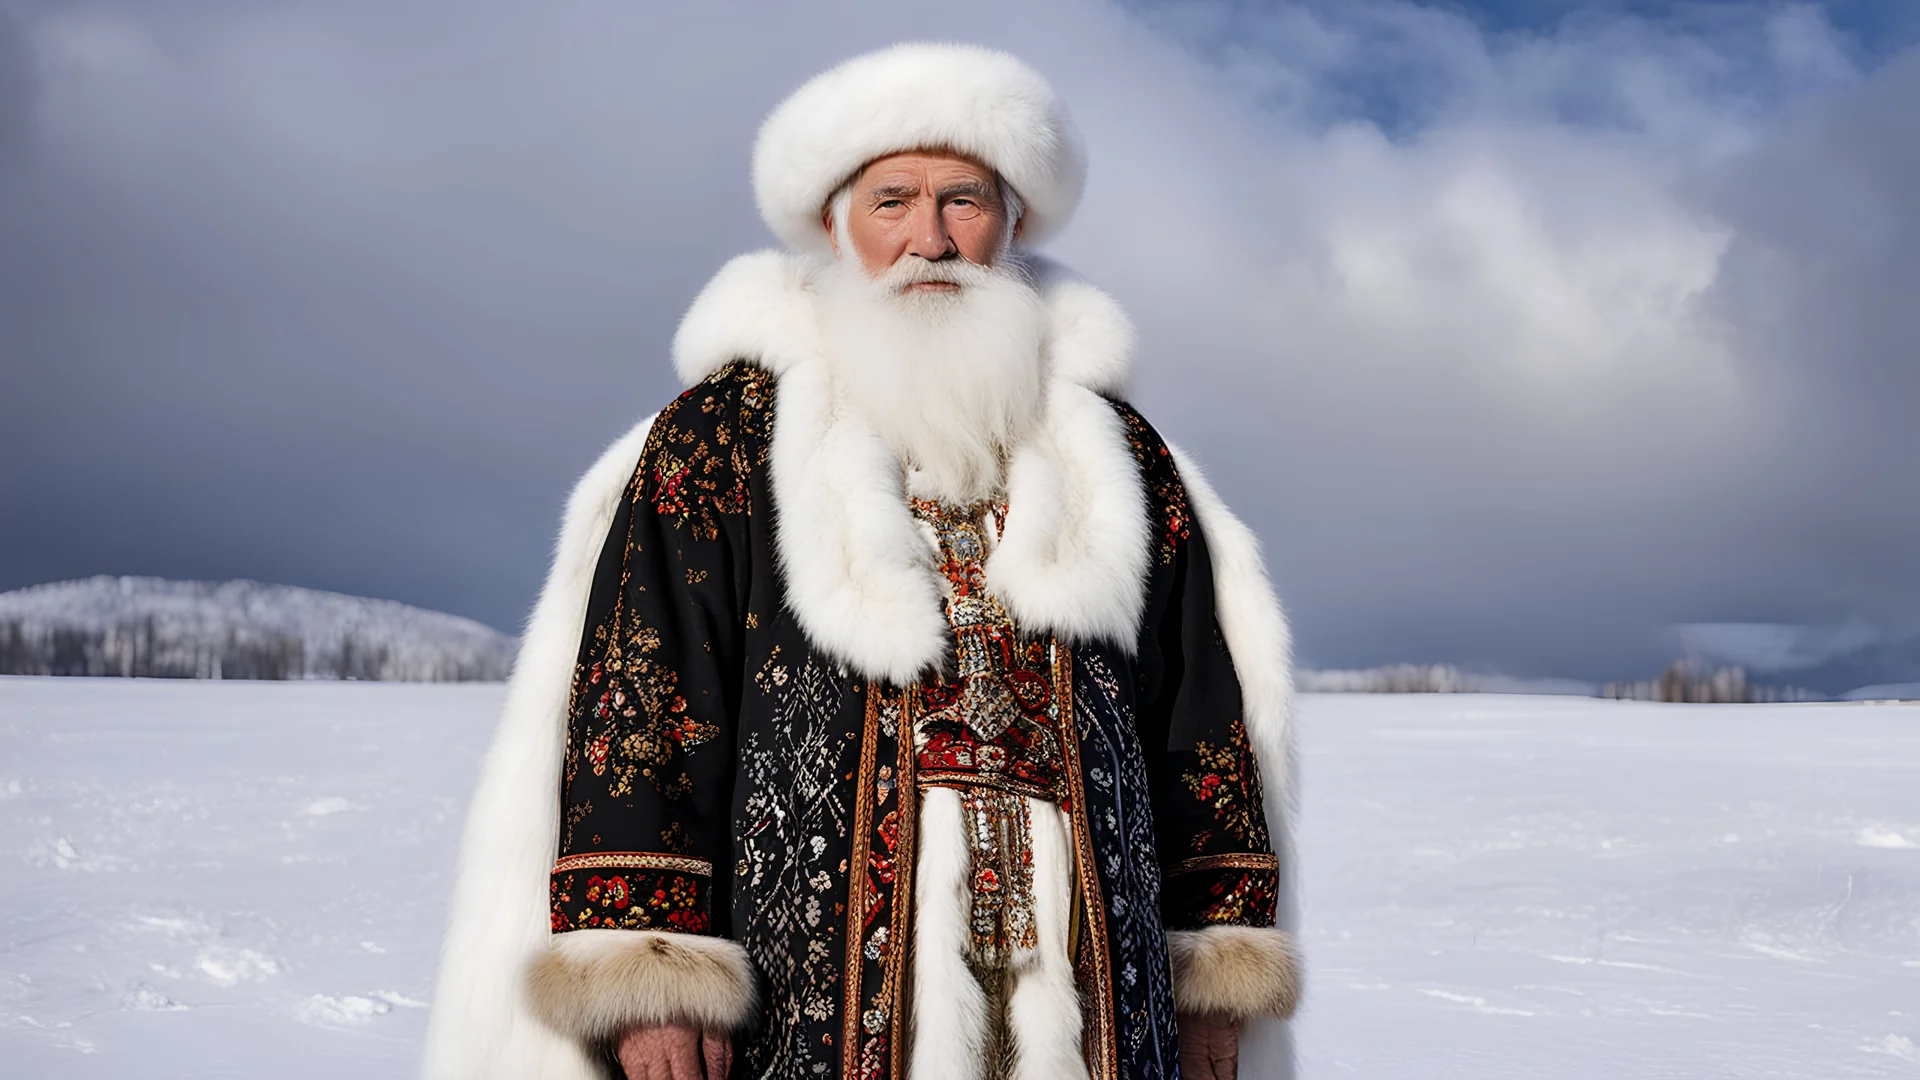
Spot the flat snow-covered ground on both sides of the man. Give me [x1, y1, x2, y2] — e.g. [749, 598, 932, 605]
[0, 678, 1920, 1080]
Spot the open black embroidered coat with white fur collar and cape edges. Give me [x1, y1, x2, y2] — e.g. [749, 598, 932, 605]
[412, 254, 1298, 1080]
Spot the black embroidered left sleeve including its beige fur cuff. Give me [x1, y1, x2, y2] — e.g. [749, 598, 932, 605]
[528, 365, 772, 1042]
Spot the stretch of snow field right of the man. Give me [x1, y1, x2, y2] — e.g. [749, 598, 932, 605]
[1298, 696, 1920, 1080]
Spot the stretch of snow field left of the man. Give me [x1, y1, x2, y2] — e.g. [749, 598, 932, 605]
[0, 678, 501, 1080]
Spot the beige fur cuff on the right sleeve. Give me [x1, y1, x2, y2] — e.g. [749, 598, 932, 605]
[1167, 926, 1300, 1020]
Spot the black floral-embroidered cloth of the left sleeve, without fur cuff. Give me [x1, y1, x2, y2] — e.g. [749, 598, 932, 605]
[549, 365, 772, 934]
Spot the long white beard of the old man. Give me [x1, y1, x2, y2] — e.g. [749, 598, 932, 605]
[820, 252, 1048, 505]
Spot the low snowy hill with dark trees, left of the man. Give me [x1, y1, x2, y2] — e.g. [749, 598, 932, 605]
[0, 577, 516, 682]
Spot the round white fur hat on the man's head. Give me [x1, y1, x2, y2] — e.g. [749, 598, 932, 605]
[753, 42, 1087, 252]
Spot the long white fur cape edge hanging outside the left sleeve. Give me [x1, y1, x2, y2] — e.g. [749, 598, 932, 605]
[420, 419, 653, 1080]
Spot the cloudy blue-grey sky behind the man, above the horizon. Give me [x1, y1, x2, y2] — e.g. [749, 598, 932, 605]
[0, 0, 1920, 680]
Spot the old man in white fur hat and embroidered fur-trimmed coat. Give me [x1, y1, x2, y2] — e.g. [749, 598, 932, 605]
[426, 44, 1298, 1080]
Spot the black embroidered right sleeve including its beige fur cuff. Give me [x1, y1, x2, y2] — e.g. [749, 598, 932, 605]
[1119, 405, 1298, 1019]
